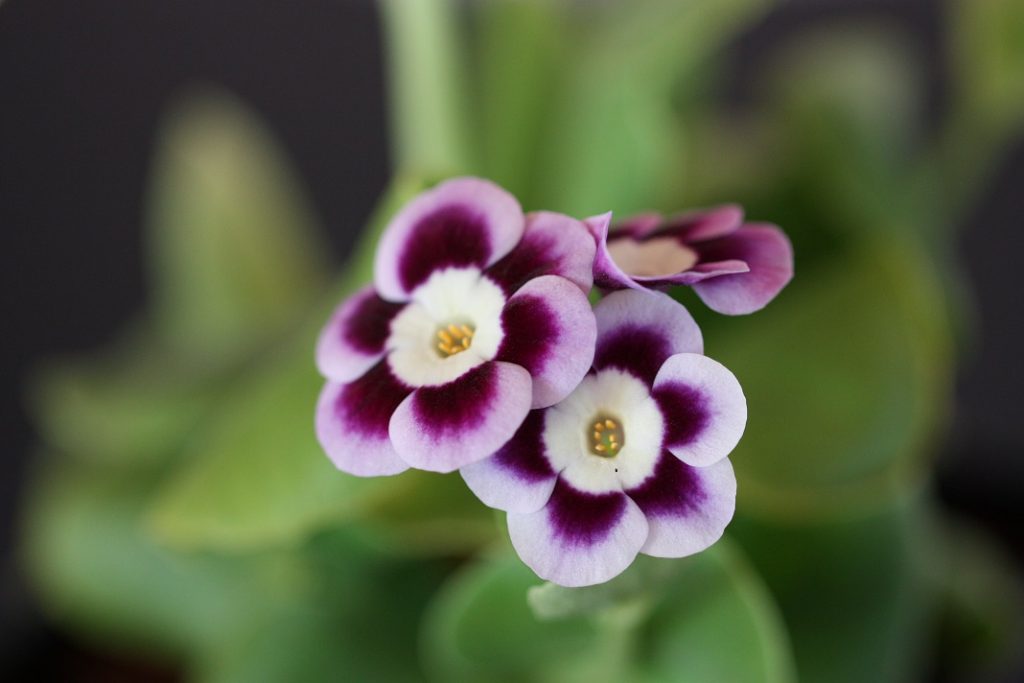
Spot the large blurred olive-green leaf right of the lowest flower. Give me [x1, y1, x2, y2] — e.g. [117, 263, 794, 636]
[707, 240, 951, 518]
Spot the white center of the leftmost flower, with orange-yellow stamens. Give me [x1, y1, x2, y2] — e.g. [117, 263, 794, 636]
[387, 268, 505, 387]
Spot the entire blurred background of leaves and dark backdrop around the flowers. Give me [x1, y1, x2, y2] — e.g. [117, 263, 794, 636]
[0, 0, 1024, 682]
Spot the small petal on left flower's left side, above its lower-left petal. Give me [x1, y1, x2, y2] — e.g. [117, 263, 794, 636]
[316, 287, 403, 382]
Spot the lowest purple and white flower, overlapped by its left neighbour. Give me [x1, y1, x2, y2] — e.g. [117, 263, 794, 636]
[461, 290, 746, 586]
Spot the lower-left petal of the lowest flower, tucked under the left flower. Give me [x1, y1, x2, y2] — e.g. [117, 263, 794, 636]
[459, 411, 558, 513]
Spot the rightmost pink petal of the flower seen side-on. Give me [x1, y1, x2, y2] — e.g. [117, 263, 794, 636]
[693, 224, 793, 315]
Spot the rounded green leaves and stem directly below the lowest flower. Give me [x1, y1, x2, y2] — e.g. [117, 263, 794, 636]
[423, 542, 794, 683]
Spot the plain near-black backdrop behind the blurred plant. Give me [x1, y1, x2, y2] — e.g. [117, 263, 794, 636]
[0, 0, 1024, 681]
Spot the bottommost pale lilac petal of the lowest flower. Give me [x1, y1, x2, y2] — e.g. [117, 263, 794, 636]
[508, 480, 647, 587]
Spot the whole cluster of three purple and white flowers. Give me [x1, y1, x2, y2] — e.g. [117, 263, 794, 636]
[316, 178, 793, 586]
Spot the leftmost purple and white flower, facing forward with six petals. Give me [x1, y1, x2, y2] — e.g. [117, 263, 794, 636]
[315, 178, 596, 476]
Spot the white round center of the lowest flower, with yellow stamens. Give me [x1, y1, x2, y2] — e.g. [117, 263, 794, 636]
[544, 370, 665, 493]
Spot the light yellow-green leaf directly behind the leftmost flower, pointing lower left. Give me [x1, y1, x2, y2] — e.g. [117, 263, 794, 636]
[143, 178, 423, 551]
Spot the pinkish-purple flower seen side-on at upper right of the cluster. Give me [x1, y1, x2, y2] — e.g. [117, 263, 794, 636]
[587, 205, 793, 315]
